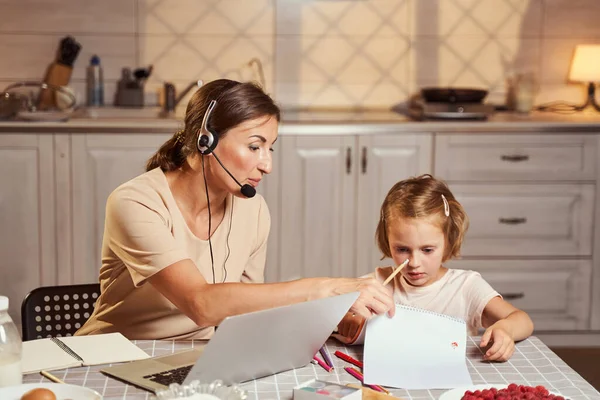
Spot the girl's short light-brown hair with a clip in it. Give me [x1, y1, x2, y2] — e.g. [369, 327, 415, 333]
[375, 174, 469, 262]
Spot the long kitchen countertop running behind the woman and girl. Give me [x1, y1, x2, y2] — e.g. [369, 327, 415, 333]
[0, 108, 600, 135]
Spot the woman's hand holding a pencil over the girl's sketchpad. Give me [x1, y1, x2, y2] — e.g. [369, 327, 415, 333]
[327, 277, 396, 319]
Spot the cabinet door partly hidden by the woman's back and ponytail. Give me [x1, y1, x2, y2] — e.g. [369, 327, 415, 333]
[72, 134, 170, 283]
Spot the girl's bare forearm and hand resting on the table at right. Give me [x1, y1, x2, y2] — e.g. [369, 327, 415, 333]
[480, 297, 533, 361]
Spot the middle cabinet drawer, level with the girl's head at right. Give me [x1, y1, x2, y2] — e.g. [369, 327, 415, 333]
[450, 184, 595, 257]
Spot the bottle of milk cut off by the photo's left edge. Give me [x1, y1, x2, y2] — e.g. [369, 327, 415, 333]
[0, 296, 23, 387]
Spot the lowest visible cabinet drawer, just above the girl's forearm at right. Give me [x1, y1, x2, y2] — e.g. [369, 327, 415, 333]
[448, 260, 592, 331]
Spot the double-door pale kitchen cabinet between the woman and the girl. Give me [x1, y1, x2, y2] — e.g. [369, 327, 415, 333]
[274, 134, 431, 281]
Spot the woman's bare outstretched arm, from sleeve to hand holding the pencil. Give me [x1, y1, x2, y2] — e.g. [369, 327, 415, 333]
[148, 259, 395, 327]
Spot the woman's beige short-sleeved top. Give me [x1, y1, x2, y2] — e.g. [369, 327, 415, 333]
[77, 168, 271, 339]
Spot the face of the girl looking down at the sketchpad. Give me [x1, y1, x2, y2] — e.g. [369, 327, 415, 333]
[388, 218, 445, 286]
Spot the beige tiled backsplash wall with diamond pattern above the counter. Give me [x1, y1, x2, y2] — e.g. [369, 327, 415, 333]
[0, 0, 600, 107]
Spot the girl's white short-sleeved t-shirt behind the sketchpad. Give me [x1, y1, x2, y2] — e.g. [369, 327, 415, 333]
[354, 267, 502, 344]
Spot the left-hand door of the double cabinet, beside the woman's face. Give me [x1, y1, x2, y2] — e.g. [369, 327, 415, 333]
[278, 136, 356, 281]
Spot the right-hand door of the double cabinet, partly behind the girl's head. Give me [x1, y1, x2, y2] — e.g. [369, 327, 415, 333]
[356, 133, 432, 275]
